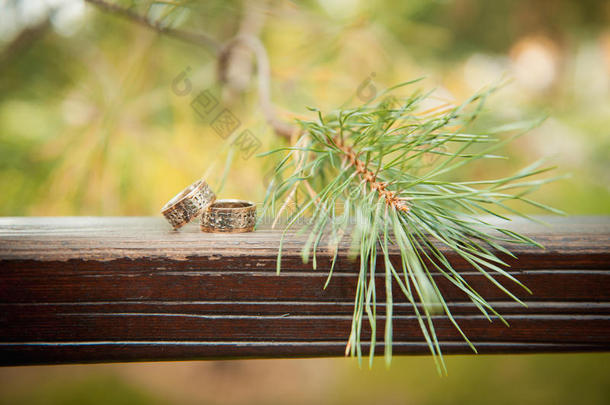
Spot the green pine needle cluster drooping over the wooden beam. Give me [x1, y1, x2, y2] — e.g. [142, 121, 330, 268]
[256, 81, 557, 373]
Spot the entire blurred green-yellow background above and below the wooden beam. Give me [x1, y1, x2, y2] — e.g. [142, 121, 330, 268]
[0, 0, 610, 404]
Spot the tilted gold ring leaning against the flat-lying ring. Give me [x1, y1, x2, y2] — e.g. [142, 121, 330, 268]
[161, 180, 216, 229]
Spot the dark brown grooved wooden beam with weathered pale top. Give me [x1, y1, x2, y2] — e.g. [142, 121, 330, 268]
[0, 217, 610, 365]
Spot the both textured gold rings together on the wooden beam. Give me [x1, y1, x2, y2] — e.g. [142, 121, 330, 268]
[161, 180, 256, 232]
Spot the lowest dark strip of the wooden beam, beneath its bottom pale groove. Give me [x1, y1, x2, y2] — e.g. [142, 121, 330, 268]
[0, 341, 610, 366]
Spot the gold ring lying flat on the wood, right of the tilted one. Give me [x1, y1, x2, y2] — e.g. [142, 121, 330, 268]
[201, 200, 256, 233]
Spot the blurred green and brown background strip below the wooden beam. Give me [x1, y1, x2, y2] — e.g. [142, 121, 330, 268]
[0, 353, 610, 405]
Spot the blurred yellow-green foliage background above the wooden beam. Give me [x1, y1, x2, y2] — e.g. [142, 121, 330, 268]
[0, 0, 610, 215]
